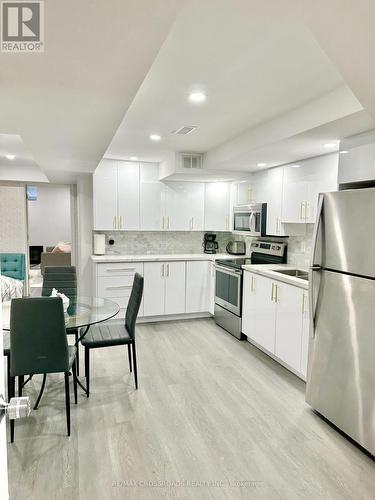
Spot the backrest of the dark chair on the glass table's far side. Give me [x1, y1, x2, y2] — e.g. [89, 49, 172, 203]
[42, 266, 77, 299]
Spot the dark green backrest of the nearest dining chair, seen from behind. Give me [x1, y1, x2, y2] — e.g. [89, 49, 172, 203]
[10, 297, 69, 376]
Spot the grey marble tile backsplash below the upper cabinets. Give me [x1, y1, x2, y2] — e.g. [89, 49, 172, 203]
[94, 224, 314, 267]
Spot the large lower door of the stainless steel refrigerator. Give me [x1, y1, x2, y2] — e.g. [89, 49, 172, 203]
[306, 271, 375, 454]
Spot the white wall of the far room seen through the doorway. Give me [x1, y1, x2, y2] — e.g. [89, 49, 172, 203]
[28, 184, 72, 246]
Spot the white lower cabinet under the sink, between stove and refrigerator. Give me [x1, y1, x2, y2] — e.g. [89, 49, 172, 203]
[242, 272, 309, 377]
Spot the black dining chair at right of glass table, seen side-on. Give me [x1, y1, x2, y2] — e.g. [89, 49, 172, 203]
[81, 273, 143, 397]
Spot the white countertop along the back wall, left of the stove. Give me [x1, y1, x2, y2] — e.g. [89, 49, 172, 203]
[91, 253, 233, 263]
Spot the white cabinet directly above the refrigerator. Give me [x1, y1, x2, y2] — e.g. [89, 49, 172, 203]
[338, 140, 375, 184]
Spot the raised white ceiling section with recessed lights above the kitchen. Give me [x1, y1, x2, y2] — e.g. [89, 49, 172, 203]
[106, 0, 373, 169]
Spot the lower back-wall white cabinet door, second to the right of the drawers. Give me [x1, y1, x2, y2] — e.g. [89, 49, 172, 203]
[165, 262, 186, 314]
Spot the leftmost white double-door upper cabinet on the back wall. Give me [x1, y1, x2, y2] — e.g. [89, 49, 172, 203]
[93, 160, 139, 230]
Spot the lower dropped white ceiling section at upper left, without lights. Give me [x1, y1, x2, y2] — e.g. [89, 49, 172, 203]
[0, 0, 183, 179]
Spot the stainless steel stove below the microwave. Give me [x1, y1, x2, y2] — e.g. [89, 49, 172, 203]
[214, 241, 287, 339]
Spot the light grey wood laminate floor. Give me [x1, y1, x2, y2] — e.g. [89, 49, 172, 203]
[8, 319, 375, 500]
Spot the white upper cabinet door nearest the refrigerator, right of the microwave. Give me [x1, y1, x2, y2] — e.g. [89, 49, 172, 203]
[303, 153, 339, 222]
